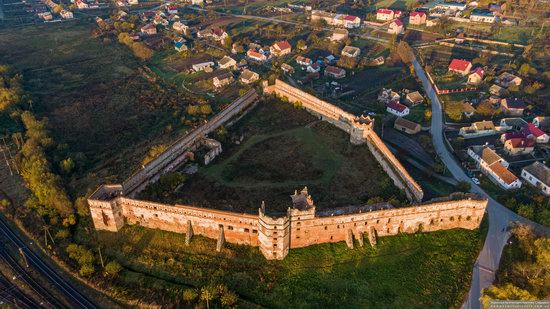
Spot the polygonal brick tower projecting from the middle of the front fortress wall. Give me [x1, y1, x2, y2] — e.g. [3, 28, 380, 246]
[258, 202, 290, 260]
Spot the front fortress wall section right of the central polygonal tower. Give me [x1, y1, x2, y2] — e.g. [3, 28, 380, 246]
[290, 200, 487, 248]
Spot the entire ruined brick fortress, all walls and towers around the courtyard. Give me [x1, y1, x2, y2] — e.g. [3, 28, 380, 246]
[88, 80, 487, 259]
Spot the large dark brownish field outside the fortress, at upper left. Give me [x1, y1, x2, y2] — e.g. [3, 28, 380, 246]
[0, 22, 194, 194]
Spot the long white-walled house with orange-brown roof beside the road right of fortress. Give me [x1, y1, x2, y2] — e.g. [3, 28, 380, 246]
[467, 145, 521, 190]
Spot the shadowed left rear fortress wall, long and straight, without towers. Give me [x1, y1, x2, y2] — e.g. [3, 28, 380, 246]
[122, 89, 259, 195]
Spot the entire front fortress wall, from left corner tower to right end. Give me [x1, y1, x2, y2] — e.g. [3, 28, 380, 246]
[88, 185, 487, 259]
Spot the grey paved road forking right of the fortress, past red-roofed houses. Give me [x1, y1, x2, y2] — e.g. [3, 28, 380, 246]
[413, 59, 550, 309]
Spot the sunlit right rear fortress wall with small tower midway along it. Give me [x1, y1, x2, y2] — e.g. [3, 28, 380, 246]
[264, 80, 424, 202]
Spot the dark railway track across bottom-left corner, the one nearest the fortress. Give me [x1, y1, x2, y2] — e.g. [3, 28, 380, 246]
[0, 217, 97, 308]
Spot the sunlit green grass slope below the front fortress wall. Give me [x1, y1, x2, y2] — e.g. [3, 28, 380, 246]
[92, 220, 490, 308]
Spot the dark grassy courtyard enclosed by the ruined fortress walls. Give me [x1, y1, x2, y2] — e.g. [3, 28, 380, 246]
[142, 99, 404, 213]
